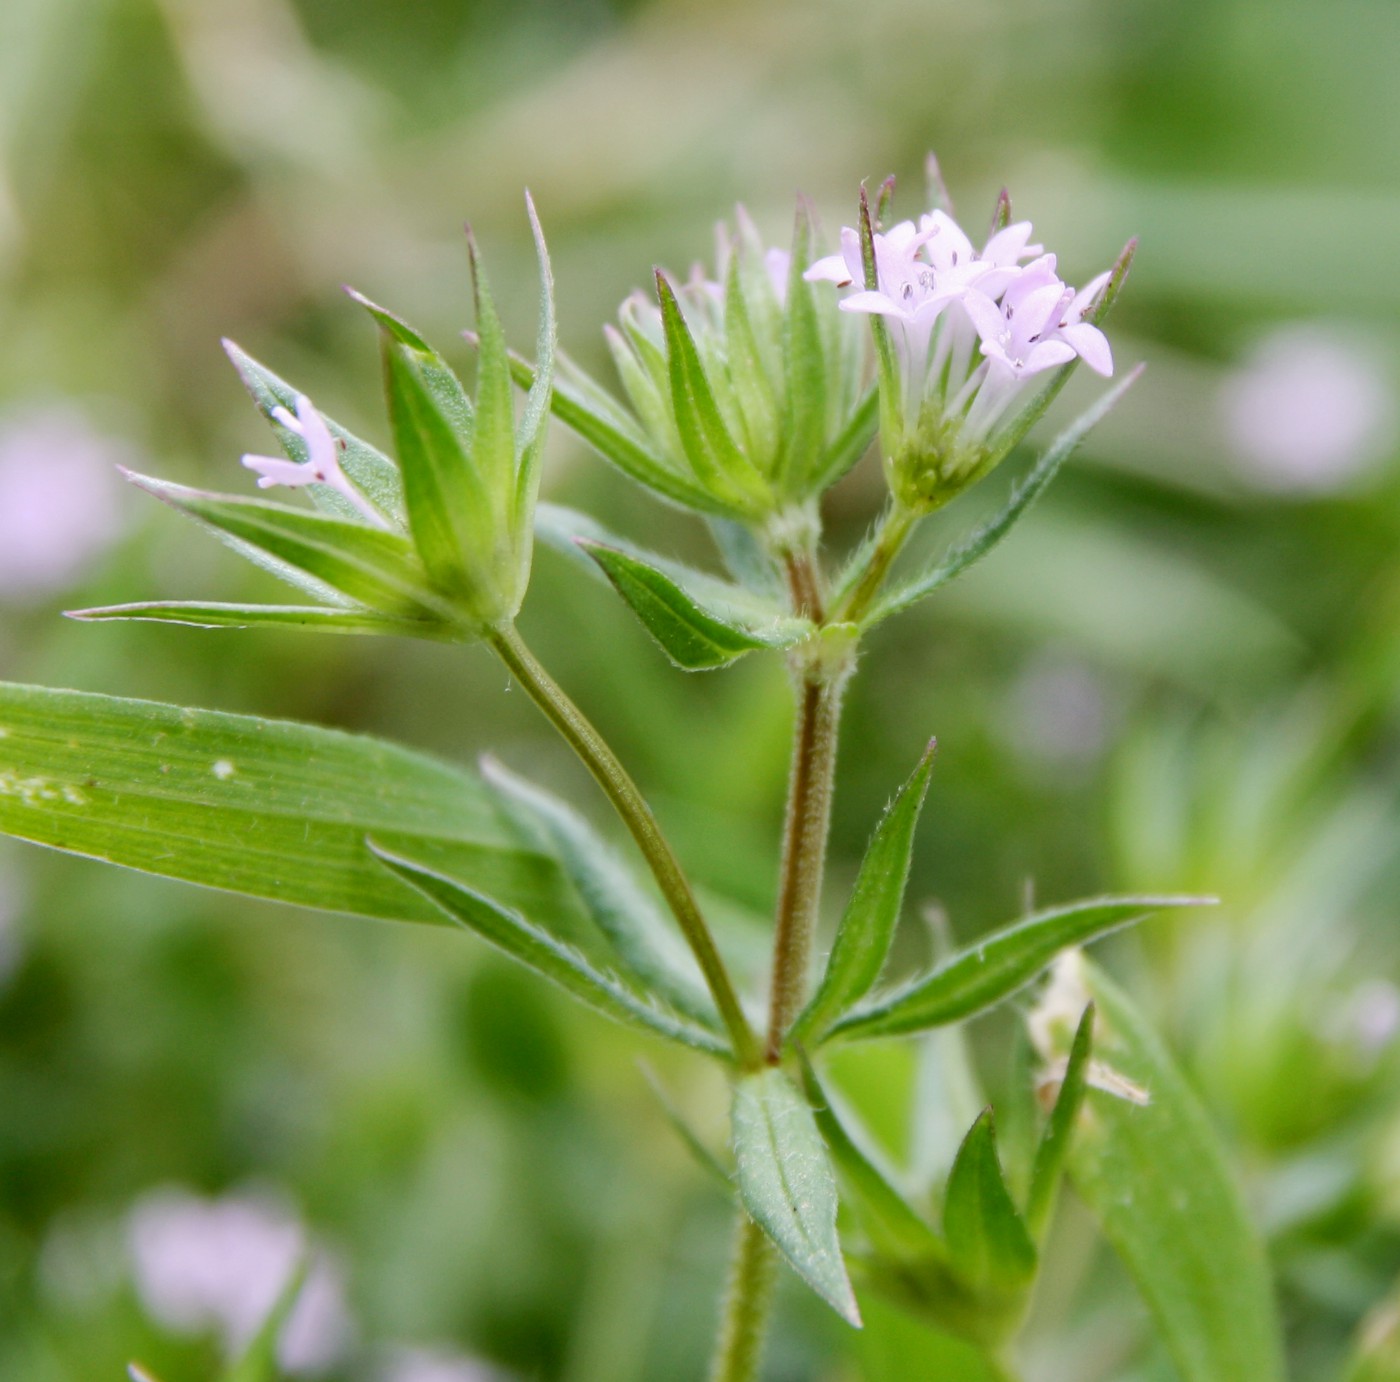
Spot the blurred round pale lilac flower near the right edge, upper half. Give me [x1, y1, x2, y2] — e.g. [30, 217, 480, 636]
[1219, 323, 1400, 493]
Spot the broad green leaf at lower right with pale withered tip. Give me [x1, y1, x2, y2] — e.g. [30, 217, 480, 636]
[1070, 965, 1284, 1382]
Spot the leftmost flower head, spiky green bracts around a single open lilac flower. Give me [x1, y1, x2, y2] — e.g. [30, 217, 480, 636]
[83, 197, 556, 638]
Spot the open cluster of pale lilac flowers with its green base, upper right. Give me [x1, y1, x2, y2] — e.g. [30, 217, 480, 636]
[805, 200, 1113, 508]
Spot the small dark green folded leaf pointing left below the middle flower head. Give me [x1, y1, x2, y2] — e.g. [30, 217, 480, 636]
[575, 539, 813, 672]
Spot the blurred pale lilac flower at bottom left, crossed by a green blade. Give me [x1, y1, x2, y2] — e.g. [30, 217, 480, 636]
[127, 1187, 354, 1374]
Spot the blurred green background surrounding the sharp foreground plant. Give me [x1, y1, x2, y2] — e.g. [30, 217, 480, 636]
[0, 0, 1400, 1382]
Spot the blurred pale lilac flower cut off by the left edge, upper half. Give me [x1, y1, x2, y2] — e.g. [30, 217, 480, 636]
[0, 403, 132, 593]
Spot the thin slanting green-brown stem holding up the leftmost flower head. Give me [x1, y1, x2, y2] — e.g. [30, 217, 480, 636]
[487, 624, 759, 1067]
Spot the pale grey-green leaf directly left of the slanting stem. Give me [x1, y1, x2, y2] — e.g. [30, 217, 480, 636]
[482, 759, 720, 1031]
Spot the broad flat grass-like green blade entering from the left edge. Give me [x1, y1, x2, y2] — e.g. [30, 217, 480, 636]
[0, 683, 577, 921]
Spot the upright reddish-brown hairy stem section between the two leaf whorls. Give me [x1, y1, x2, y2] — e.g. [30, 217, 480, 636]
[764, 662, 850, 1066]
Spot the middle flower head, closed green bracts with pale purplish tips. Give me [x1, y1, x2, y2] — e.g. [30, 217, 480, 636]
[537, 207, 876, 525]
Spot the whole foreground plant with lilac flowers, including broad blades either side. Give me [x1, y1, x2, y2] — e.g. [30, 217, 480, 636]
[0, 169, 1280, 1382]
